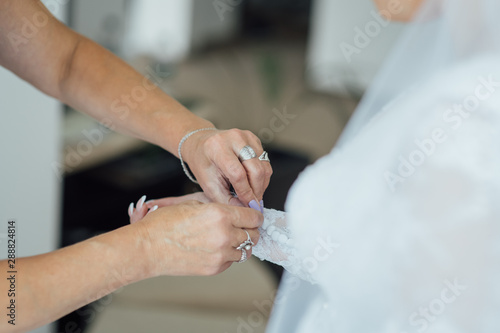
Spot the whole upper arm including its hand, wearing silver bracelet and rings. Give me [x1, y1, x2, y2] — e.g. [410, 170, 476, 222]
[0, 0, 272, 205]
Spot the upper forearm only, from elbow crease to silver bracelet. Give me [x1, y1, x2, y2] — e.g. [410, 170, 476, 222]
[56, 33, 213, 154]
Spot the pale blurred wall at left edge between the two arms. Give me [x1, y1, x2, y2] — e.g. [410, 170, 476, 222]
[0, 0, 66, 333]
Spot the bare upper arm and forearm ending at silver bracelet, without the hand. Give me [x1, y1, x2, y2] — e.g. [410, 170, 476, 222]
[0, 0, 213, 154]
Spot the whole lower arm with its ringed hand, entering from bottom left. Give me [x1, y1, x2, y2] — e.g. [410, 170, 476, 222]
[0, 201, 262, 332]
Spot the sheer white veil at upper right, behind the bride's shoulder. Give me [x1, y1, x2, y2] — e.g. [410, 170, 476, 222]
[338, 0, 500, 145]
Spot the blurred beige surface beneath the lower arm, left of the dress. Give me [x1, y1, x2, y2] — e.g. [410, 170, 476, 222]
[88, 258, 276, 333]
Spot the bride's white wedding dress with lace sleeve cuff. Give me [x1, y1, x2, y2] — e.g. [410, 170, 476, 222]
[253, 0, 500, 333]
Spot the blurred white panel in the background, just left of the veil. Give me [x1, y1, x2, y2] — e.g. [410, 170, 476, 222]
[307, 0, 401, 94]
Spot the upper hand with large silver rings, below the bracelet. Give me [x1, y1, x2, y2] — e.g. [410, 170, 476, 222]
[182, 129, 273, 211]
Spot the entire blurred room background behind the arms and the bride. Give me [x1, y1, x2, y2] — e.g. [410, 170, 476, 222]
[0, 0, 401, 333]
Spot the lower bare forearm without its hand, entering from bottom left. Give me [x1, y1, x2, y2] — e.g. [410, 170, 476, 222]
[0, 225, 152, 332]
